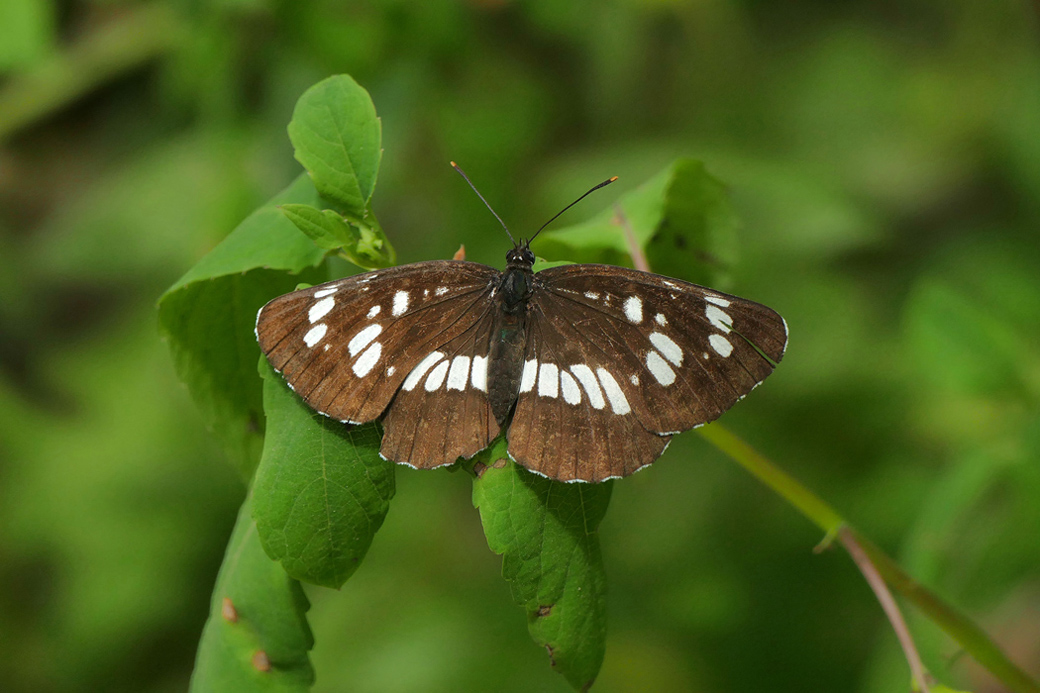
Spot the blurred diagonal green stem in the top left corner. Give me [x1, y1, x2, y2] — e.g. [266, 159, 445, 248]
[0, 2, 182, 142]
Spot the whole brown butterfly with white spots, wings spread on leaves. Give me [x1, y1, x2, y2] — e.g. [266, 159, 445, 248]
[256, 164, 787, 482]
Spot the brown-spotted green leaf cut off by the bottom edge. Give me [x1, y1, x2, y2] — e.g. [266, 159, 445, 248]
[190, 491, 314, 693]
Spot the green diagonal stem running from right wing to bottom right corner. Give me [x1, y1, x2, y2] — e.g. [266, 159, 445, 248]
[698, 424, 1040, 693]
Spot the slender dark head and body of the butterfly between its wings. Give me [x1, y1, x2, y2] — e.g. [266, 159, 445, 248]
[488, 247, 535, 426]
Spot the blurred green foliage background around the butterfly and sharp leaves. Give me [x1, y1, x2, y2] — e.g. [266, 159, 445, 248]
[0, 0, 1040, 693]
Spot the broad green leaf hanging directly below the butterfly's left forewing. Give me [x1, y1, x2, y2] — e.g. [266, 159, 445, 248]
[254, 359, 394, 588]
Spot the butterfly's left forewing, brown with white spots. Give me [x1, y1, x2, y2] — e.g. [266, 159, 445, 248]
[257, 261, 492, 426]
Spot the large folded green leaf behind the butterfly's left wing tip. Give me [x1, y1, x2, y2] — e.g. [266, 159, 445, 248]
[159, 176, 324, 479]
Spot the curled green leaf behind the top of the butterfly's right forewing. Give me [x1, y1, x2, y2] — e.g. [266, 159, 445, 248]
[536, 159, 737, 285]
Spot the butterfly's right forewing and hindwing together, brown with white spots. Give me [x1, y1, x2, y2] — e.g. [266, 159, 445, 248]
[509, 265, 786, 481]
